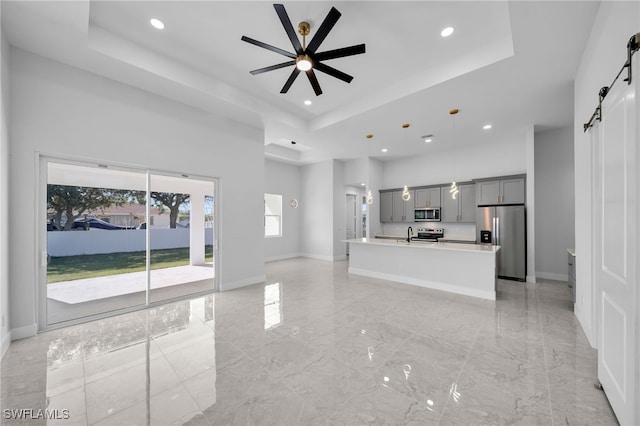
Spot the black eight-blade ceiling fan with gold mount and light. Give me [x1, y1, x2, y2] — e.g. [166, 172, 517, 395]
[242, 4, 365, 96]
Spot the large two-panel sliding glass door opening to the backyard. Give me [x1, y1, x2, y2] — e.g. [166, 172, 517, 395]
[40, 159, 216, 329]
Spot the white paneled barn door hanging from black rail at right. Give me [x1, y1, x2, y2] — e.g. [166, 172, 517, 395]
[592, 57, 640, 425]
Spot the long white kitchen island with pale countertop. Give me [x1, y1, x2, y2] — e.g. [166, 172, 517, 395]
[346, 238, 500, 300]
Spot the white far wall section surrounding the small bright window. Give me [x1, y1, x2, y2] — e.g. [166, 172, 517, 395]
[263, 160, 302, 262]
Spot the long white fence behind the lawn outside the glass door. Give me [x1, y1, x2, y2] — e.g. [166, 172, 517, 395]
[47, 228, 213, 257]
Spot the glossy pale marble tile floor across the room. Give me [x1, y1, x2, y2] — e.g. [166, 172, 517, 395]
[0, 258, 617, 426]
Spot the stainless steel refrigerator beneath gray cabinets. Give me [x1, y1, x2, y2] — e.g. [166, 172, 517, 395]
[476, 205, 527, 281]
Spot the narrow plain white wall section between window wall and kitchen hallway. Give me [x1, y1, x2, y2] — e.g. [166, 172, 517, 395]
[300, 160, 334, 260]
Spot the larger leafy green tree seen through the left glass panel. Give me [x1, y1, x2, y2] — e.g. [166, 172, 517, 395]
[47, 185, 128, 231]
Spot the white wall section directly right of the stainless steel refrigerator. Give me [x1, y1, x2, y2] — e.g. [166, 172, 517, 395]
[535, 127, 575, 281]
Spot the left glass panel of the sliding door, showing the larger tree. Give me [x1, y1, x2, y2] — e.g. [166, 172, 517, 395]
[46, 161, 146, 325]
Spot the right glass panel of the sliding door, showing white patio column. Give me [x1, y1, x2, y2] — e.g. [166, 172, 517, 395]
[148, 174, 214, 303]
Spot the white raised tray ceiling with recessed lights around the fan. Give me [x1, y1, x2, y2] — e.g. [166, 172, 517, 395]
[2, 0, 599, 163]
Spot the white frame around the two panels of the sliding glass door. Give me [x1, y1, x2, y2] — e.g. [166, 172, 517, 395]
[34, 151, 221, 332]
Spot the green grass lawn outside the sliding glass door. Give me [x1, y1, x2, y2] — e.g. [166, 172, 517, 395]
[47, 246, 213, 284]
